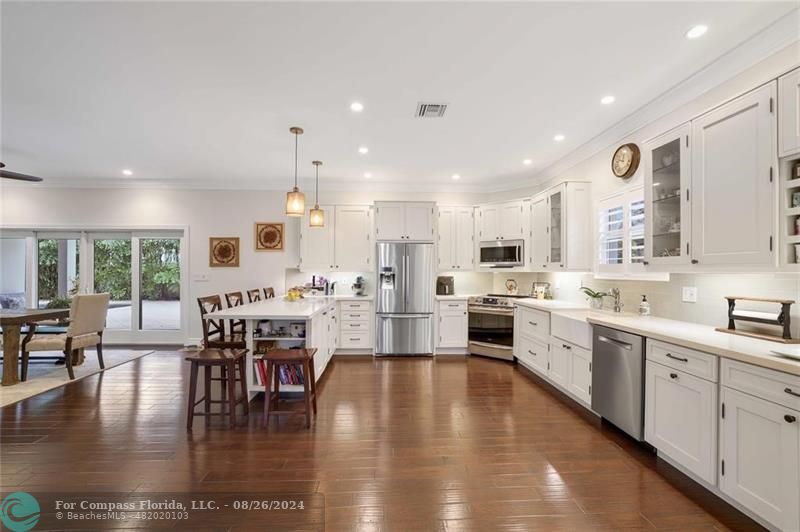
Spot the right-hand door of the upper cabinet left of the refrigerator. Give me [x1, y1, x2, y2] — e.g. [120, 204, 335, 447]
[334, 205, 372, 272]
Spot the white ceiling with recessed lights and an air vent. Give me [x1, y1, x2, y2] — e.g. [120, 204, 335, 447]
[0, 1, 797, 189]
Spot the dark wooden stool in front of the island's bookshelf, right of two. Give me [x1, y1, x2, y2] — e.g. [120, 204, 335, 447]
[260, 347, 317, 428]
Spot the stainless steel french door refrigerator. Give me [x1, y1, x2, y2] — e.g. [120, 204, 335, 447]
[375, 242, 434, 356]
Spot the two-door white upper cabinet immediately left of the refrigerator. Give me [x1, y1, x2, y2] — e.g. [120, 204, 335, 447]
[300, 205, 372, 272]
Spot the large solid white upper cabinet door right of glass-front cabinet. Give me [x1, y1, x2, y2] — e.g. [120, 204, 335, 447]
[690, 83, 777, 266]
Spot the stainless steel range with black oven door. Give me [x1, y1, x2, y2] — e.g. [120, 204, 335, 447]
[468, 294, 528, 361]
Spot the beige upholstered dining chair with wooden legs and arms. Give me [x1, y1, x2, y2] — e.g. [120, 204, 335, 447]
[21, 293, 111, 381]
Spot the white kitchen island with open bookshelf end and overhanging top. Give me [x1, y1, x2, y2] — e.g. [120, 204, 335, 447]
[208, 296, 341, 399]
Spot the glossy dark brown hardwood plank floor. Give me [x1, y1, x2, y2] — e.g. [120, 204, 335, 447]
[0, 353, 759, 531]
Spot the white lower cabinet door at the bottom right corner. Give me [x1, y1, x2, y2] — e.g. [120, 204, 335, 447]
[719, 386, 800, 530]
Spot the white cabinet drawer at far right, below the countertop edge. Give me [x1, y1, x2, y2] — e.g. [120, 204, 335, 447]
[722, 359, 800, 410]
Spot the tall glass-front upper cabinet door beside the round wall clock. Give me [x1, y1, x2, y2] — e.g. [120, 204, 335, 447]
[643, 124, 691, 265]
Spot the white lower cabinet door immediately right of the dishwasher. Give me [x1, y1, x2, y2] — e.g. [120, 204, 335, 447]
[644, 361, 717, 485]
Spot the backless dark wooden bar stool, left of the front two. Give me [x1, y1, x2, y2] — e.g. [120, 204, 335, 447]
[186, 349, 250, 430]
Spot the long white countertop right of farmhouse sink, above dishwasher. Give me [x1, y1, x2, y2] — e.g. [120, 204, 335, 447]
[576, 310, 800, 376]
